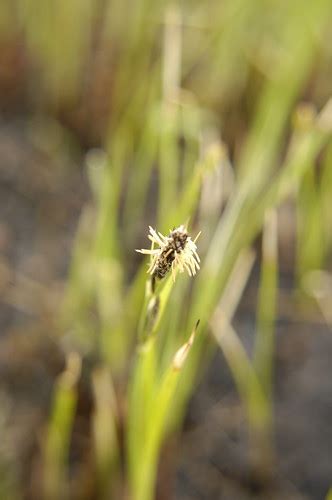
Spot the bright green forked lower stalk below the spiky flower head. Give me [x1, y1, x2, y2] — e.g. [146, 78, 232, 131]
[128, 324, 198, 500]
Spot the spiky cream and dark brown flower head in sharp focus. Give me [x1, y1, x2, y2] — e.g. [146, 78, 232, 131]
[136, 225, 200, 280]
